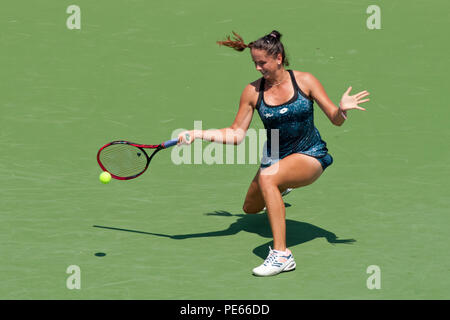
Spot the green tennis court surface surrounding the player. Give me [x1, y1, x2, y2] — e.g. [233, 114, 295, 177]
[0, 0, 450, 300]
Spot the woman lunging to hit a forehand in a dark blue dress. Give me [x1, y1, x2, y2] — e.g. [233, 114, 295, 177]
[178, 30, 369, 276]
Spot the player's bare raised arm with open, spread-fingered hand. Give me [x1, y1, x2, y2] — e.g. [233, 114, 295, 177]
[301, 72, 370, 126]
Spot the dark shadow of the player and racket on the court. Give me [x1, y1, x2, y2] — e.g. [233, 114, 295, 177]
[94, 211, 356, 259]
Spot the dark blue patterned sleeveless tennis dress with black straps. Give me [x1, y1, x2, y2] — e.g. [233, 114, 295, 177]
[256, 70, 333, 170]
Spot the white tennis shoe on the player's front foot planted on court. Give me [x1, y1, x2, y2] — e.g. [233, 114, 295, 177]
[253, 247, 296, 277]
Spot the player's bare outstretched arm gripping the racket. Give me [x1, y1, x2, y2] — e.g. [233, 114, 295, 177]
[178, 83, 258, 145]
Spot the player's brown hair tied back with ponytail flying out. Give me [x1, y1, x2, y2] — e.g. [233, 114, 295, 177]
[217, 30, 289, 66]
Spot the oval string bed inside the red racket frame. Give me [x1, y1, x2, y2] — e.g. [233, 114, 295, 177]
[99, 144, 147, 178]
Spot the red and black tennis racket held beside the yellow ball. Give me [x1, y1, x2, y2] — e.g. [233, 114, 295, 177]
[97, 139, 178, 180]
